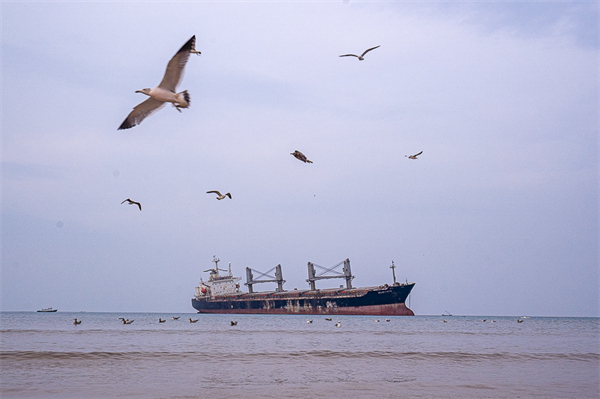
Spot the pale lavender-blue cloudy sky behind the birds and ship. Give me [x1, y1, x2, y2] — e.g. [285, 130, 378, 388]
[0, 0, 600, 317]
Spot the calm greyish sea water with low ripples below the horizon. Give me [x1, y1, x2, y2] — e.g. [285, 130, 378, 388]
[0, 312, 600, 398]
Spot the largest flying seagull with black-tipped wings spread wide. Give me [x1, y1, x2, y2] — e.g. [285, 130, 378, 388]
[118, 36, 200, 130]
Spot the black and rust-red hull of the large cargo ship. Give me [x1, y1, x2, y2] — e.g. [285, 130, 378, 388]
[192, 283, 414, 316]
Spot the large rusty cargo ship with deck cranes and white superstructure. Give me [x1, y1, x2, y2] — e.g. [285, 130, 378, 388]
[192, 257, 415, 316]
